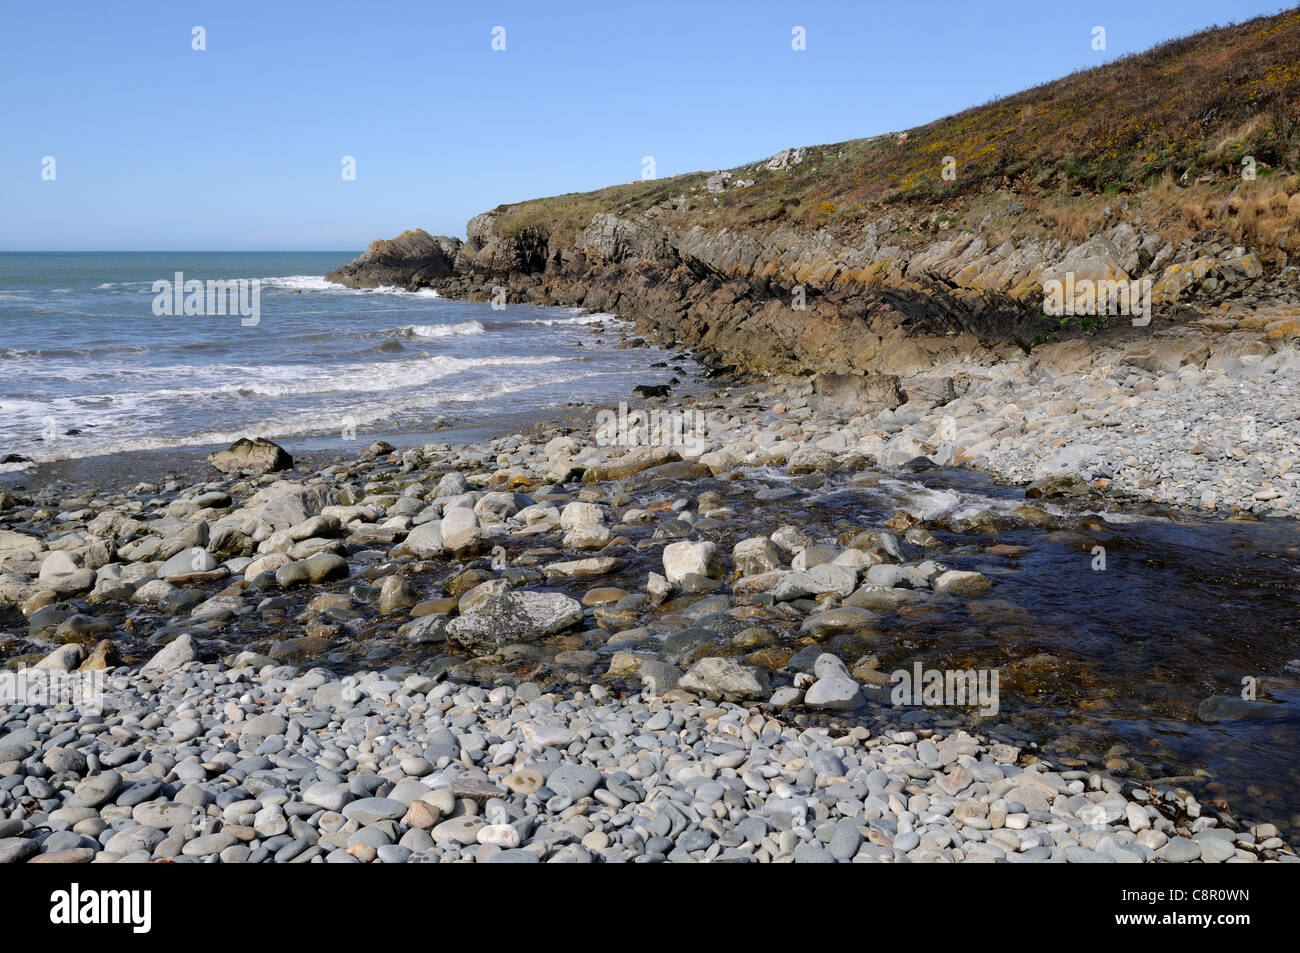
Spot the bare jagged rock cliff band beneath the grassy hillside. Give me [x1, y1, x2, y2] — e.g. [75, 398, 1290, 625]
[329, 196, 1300, 377]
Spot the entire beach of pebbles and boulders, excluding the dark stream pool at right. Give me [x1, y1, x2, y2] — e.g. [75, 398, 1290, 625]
[0, 314, 1300, 863]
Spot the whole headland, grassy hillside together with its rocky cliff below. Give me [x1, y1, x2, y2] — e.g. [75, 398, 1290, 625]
[328, 10, 1300, 374]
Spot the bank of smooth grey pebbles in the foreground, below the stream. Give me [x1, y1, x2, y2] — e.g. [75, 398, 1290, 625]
[0, 655, 1294, 863]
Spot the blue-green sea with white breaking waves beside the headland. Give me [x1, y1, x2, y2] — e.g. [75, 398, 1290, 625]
[0, 252, 671, 469]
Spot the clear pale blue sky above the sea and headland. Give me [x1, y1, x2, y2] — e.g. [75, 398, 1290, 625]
[0, 0, 1286, 251]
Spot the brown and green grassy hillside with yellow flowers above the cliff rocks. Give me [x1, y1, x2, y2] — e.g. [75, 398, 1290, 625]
[483, 9, 1300, 264]
